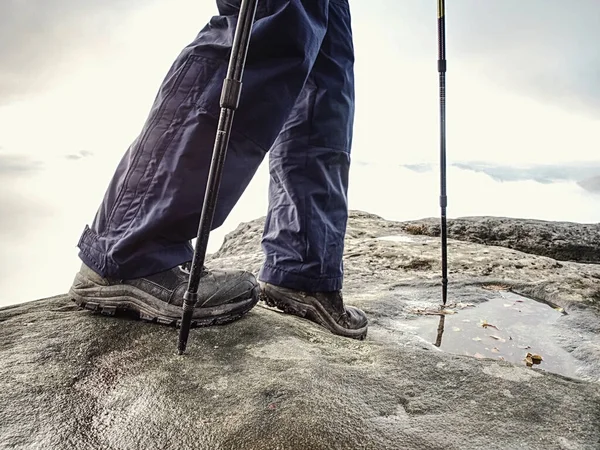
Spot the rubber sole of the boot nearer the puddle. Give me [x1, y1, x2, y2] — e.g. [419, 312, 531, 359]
[260, 285, 368, 340]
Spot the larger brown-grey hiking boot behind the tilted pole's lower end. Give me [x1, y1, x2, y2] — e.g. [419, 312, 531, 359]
[69, 264, 259, 327]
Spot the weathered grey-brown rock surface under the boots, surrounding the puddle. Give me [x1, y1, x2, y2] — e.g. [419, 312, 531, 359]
[0, 212, 600, 450]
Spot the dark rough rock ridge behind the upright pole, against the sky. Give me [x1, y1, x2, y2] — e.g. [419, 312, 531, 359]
[400, 217, 600, 264]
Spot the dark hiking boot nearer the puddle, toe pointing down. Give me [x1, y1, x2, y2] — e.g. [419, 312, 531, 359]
[259, 281, 368, 339]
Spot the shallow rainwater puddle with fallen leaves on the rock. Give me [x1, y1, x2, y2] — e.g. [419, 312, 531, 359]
[410, 291, 580, 377]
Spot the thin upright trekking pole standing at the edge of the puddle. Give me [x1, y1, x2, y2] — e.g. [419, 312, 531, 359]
[438, 0, 448, 305]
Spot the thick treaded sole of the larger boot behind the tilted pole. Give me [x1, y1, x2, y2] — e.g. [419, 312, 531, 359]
[69, 274, 260, 328]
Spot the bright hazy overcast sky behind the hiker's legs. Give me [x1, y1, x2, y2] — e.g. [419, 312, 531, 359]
[0, 0, 600, 305]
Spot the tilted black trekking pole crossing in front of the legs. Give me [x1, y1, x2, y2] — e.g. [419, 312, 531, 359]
[178, 0, 258, 355]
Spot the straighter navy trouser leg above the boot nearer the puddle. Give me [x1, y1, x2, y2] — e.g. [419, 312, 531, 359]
[259, 0, 354, 291]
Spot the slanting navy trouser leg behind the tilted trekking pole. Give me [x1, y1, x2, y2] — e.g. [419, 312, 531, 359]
[78, 0, 328, 279]
